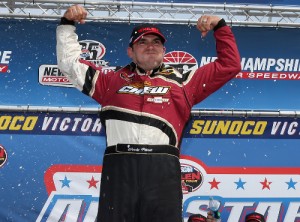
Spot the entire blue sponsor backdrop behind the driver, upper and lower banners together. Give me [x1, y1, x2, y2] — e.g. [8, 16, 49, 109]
[0, 19, 300, 222]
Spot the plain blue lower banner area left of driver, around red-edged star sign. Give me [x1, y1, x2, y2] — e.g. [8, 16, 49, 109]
[0, 133, 105, 222]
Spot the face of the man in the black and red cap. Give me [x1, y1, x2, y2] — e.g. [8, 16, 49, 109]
[127, 34, 165, 71]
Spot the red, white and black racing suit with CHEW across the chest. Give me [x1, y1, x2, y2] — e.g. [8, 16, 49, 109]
[57, 20, 240, 222]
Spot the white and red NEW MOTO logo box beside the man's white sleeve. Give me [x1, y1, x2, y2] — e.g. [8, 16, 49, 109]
[39, 65, 73, 87]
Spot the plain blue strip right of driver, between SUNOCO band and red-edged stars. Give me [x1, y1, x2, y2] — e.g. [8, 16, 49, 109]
[181, 138, 299, 167]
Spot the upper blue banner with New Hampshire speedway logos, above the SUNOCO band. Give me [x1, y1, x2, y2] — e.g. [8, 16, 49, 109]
[0, 20, 300, 110]
